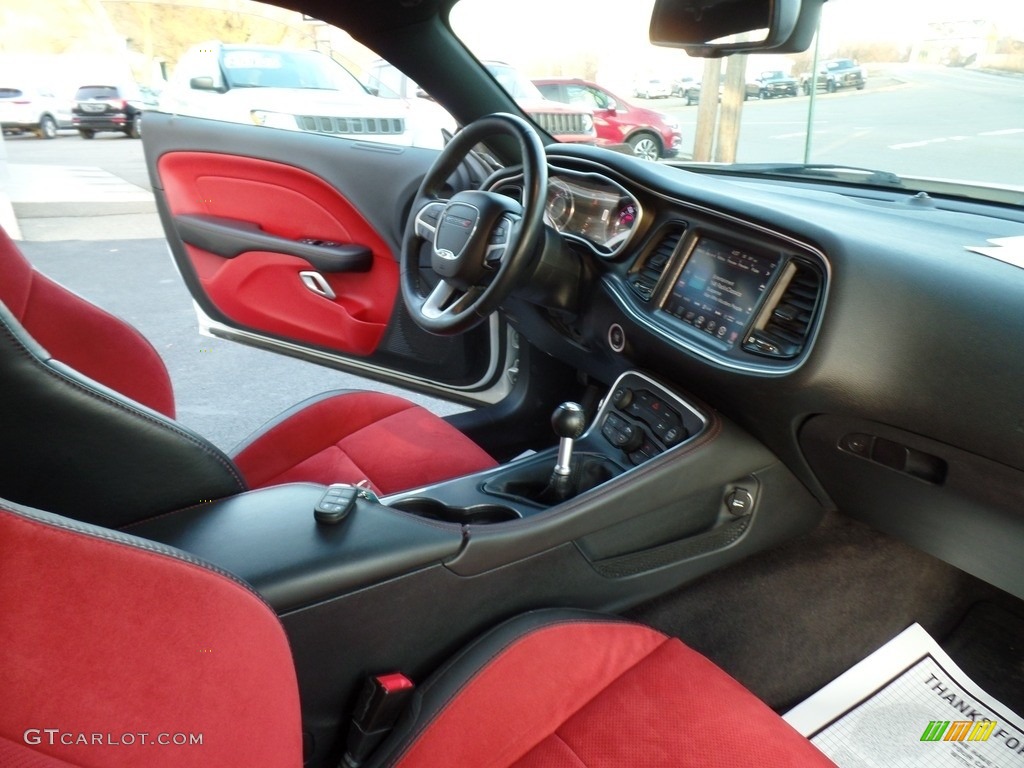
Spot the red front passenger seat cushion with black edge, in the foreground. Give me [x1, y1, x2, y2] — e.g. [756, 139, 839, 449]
[374, 610, 833, 768]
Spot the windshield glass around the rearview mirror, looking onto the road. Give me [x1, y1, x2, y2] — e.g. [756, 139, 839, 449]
[450, 0, 1024, 199]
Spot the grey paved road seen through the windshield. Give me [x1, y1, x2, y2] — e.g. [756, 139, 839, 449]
[635, 65, 1024, 186]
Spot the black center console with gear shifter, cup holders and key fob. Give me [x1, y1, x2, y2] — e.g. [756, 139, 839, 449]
[128, 372, 820, 766]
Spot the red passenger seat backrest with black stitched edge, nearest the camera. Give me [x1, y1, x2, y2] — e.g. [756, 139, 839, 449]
[0, 501, 302, 768]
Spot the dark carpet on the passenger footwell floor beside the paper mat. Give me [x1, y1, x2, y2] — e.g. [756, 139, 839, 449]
[630, 514, 1024, 712]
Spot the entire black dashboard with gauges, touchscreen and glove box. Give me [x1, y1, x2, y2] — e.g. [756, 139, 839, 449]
[492, 147, 1024, 594]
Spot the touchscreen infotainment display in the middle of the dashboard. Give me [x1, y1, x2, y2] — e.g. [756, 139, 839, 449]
[663, 238, 779, 347]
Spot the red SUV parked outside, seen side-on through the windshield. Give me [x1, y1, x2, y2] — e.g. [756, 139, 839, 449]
[534, 78, 683, 160]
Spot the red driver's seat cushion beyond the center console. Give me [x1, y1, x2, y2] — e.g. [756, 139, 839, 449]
[232, 392, 497, 494]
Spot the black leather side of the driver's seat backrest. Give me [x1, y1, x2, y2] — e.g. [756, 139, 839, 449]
[0, 303, 246, 527]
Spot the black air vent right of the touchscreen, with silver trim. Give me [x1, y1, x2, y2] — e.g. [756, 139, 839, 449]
[743, 259, 823, 358]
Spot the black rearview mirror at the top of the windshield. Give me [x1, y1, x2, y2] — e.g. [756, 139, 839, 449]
[650, 0, 824, 58]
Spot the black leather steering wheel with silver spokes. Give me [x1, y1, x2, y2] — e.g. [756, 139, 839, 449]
[400, 113, 548, 336]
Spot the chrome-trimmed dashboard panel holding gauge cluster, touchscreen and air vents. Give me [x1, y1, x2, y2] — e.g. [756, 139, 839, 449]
[492, 154, 829, 375]
